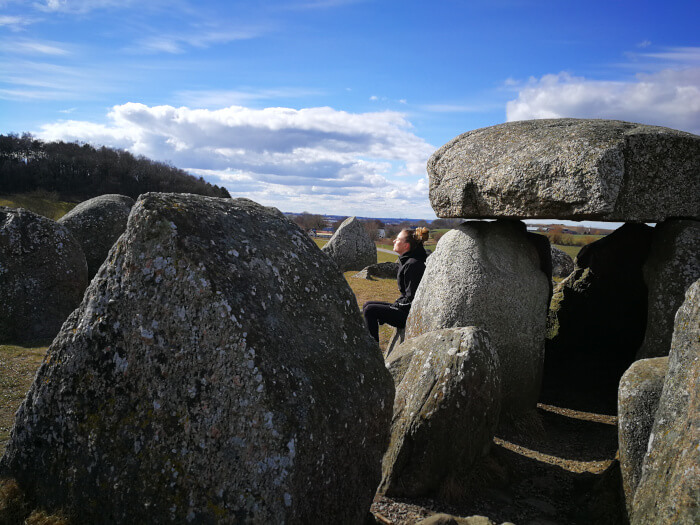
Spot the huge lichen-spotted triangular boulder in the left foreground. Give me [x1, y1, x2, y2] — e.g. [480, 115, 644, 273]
[0, 193, 394, 523]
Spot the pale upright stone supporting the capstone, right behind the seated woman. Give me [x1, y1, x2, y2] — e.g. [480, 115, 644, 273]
[406, 221, 550, 412]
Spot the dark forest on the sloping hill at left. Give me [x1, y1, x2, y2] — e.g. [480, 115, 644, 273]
[0, 133, 231, 200]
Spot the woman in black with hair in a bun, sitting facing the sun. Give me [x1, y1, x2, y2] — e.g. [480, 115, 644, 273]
[362, 228, 428, 341]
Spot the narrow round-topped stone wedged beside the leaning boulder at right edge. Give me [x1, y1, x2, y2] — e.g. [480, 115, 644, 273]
[617, 357, 668, 514]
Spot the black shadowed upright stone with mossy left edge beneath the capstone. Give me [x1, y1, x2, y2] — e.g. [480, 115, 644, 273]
[544, 223, 653, 413]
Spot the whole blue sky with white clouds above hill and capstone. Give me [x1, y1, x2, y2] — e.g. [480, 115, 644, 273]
[0, 0, 700, 219]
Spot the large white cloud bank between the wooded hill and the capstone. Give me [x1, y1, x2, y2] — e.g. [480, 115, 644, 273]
[38, 103, 435, 216]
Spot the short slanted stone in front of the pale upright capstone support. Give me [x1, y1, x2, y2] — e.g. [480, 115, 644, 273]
[379, 327, 500, 497]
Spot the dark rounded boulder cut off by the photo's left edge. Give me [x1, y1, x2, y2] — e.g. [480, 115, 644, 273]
[0, 206, 88, 343]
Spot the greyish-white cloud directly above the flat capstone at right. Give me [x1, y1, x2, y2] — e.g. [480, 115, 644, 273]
[506, 67, 700, 133]
